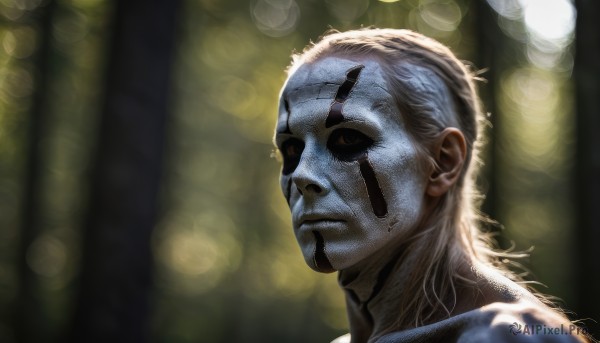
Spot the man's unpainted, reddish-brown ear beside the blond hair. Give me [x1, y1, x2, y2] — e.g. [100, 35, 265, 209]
[427, 127, 467, 197]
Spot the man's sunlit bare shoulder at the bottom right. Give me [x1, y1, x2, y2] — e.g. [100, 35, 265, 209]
[456, 300, 588, 343]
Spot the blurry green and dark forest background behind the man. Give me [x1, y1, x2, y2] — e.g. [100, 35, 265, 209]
[0, 0, 600, 342]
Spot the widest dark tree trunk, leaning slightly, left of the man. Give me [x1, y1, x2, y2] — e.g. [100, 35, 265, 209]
[70, 0, 179, 342]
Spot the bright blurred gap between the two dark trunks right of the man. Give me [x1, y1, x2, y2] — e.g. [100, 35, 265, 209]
[488, 0, 576, 307]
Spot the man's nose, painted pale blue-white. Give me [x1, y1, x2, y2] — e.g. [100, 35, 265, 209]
[292, 154, 328, 197]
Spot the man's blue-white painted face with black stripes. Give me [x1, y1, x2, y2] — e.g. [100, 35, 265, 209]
[275, 57, 427, 272]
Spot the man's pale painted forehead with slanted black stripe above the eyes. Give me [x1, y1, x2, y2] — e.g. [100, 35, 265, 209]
[277, 57, 395, 132]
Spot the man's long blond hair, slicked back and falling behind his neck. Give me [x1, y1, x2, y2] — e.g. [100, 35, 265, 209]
[288, 29, 532, 331]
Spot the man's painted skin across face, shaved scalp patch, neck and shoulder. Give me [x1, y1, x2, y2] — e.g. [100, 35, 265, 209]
[275, 57, 586, 343]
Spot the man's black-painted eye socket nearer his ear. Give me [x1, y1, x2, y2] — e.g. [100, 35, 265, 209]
[327, 129, 373, 161]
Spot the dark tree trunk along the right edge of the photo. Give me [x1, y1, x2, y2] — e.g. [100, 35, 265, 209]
[573, 0, 600, 333]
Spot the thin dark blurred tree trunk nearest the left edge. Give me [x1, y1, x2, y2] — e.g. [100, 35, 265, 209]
[13, 1, 55, 342]
